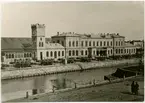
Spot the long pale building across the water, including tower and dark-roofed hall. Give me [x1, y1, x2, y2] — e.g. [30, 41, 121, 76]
[1, 24, 138, 64]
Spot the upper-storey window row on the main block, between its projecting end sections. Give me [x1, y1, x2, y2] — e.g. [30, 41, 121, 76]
[81, 41, 112, 46]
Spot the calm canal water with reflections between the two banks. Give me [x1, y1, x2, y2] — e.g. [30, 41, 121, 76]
[2, 68, 117, 101]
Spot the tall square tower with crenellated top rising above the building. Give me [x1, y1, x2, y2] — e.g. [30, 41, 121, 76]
[31, 24, 45, 60]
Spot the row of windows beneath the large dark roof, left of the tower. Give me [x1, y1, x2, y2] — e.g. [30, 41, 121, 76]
[6, 53, 31, 59]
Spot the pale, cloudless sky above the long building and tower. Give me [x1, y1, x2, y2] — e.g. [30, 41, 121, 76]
[1, 1, 144, 40]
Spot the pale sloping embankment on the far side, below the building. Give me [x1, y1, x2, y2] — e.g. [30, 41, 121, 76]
[1, 58, 140, 80]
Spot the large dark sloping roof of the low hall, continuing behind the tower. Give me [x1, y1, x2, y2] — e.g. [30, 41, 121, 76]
[1, 37, 50, 50]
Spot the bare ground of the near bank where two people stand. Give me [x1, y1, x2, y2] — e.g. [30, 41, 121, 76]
[7, 76, 144, 102]
